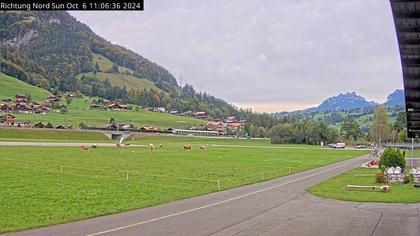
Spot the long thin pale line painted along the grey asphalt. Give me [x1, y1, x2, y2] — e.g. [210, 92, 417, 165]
[86, 158, 359, 236]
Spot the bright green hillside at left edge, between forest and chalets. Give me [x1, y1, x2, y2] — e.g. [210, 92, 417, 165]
[0, 72, 51, 101]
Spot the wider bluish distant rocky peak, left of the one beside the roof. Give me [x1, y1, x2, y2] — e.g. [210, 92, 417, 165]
[304, 92, 376, 112]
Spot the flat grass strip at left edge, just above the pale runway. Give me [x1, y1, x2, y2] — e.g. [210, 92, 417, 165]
[0, 128, 112, 142]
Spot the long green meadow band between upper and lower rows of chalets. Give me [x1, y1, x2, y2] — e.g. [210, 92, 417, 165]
[9, 98, 206, 130]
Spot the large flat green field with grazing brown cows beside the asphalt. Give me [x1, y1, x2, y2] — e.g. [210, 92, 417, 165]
[0, 142, 365, 232]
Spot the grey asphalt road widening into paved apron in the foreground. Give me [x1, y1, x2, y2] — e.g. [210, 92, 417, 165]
[6, 157, 420, 236]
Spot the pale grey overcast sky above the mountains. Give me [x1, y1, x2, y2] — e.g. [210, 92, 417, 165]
[71, 0, 402, 112]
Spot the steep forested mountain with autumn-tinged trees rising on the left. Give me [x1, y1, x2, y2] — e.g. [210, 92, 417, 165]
[0, 11, 237, 117]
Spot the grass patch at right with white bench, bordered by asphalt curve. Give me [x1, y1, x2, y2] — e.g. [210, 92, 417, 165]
[309, 168, 420, 203]
